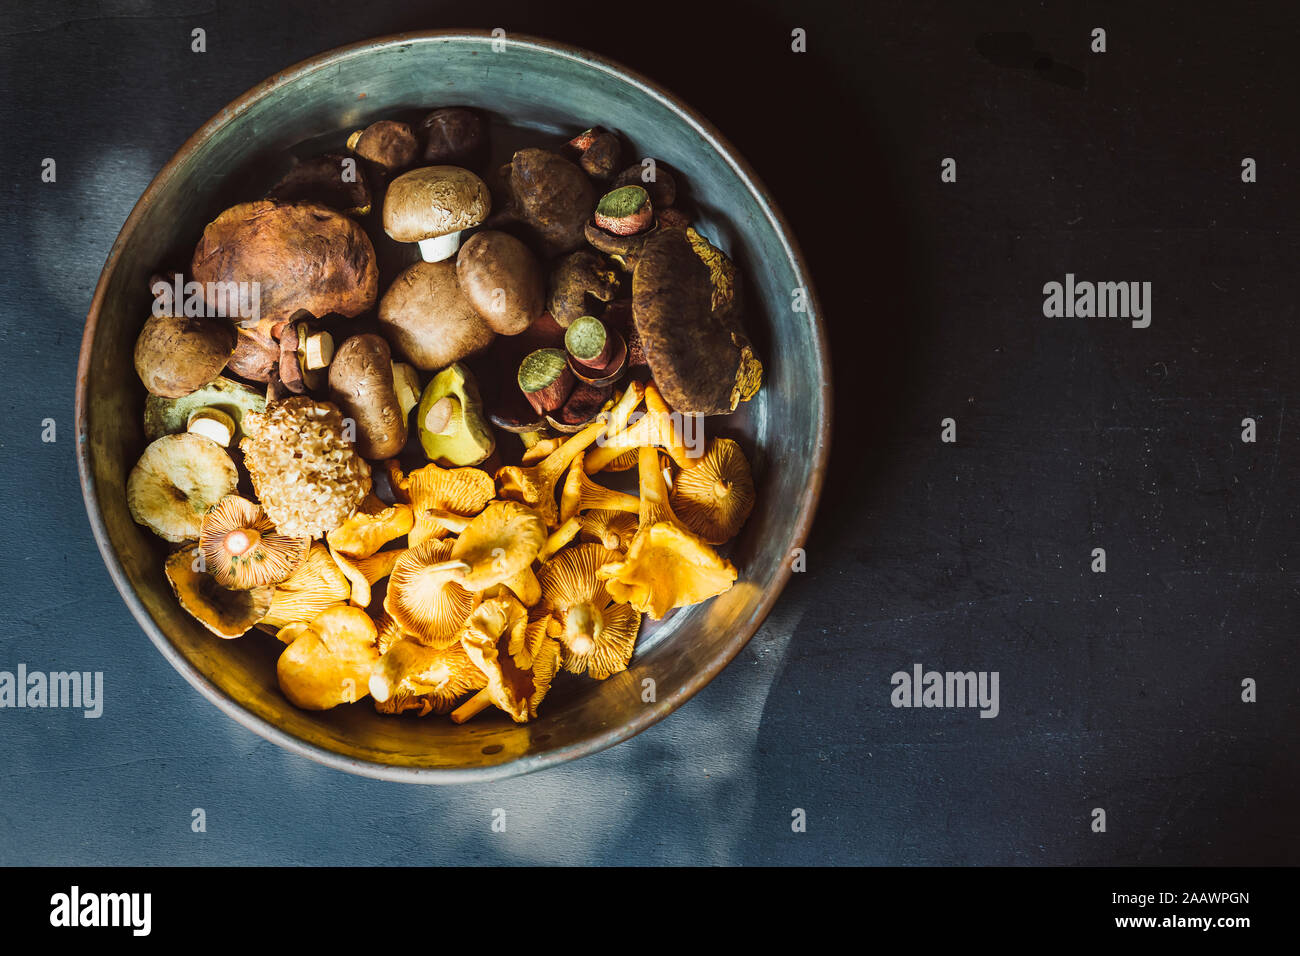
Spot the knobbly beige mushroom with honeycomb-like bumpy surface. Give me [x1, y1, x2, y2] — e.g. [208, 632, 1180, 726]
[239, 395, 371, 538]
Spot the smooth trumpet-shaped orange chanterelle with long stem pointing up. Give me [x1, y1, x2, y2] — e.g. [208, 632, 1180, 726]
[598, 447, 736, 620]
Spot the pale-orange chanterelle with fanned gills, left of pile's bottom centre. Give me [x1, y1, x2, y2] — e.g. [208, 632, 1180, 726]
[384, 538, 476, 648]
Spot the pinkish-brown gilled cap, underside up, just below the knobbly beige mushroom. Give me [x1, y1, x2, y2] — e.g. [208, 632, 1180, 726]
[199, 494, 311, 591]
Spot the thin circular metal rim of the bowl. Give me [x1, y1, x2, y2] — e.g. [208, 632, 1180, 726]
[75, 29, 832, 784]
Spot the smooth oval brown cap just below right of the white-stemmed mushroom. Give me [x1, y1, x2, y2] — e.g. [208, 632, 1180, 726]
[456, 229, 546, 336]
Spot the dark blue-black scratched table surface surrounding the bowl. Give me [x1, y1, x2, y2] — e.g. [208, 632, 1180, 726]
[0, 0, 1300, 865]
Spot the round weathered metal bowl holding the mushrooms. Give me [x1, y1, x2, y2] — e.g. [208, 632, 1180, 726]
[77, 31, 831, 783]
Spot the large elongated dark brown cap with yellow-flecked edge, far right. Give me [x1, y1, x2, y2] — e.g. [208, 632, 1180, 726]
[632, 229, 762, 415]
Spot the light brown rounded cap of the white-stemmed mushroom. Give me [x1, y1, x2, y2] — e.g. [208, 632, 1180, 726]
[384, 166, 491, 242]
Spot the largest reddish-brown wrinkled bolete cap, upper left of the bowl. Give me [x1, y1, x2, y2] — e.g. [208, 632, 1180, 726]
[191, 199, 380, 336]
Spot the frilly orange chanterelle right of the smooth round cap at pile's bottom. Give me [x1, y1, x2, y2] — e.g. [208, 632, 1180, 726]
[371, 639, 488, 717]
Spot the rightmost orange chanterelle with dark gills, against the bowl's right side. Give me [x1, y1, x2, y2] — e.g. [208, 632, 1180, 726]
[668, 438, 754, 545]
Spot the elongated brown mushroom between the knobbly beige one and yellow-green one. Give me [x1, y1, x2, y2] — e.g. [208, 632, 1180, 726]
[329, 333, 407, 459]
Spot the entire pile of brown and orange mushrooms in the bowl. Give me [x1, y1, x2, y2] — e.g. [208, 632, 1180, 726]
[126, 107, 762, 723]
